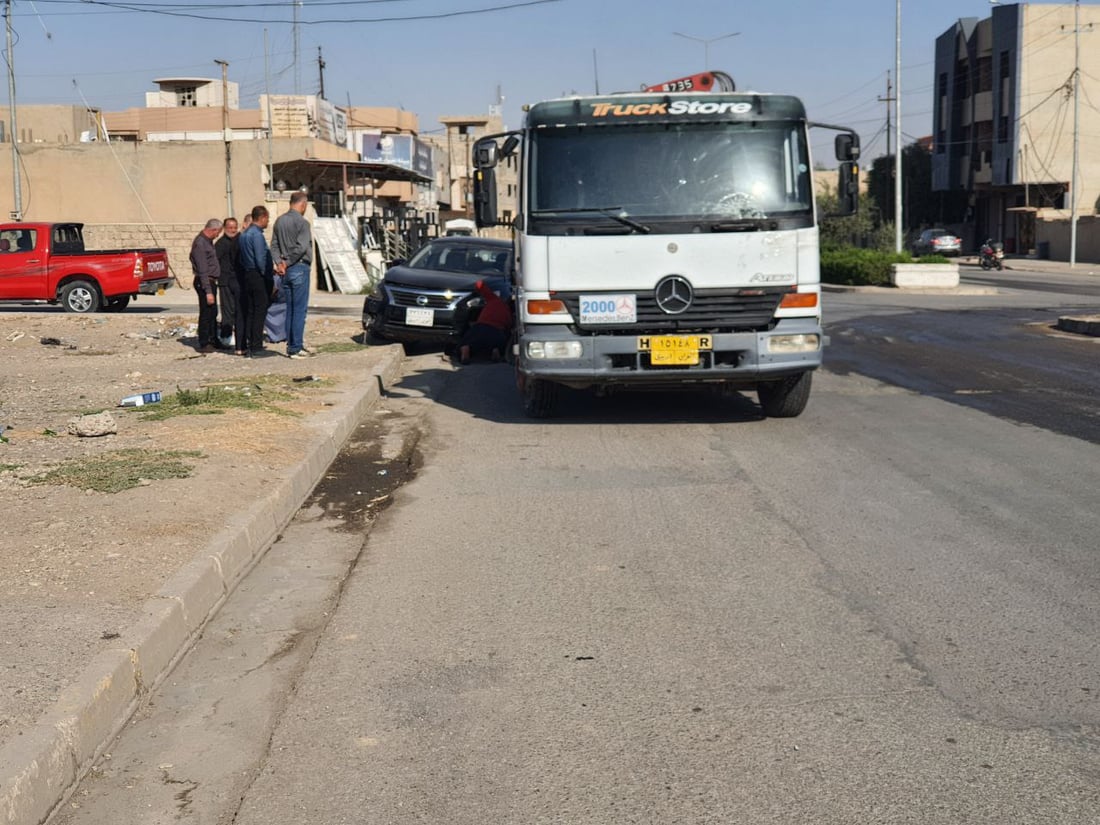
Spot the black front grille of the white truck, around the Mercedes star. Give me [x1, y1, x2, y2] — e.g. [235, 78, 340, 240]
[553, 287, 790, 332]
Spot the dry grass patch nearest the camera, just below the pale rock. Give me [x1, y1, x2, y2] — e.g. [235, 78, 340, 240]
[30, 449, 204, 493]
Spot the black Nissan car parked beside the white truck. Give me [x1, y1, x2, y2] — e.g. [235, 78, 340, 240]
[363, 237, 512, 345]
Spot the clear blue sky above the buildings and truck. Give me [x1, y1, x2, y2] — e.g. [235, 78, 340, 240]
[0, 0, 1060, 162]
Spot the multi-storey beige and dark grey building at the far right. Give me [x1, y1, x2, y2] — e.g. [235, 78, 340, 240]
[932, 3, 1100, 261]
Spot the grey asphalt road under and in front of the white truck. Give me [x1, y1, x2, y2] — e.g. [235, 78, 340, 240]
[55, 282, 1100, 825]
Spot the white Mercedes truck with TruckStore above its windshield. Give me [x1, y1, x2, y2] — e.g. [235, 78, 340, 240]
[474, 80, 859, 417]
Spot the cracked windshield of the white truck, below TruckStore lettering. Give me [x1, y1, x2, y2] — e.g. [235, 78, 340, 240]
[529, 122, 813, 224]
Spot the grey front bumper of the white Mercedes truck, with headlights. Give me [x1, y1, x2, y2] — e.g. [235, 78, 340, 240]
[517, 318, 826, 388]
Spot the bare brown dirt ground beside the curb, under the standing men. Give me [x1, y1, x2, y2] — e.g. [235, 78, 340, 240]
[0, 312, 396, 746]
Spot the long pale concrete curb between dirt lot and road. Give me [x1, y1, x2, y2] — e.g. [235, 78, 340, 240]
[0, 347, 404, 825]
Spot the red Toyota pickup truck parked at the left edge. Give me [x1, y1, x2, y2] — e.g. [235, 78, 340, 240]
[0, 223, 173, 312]
